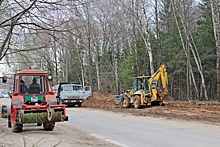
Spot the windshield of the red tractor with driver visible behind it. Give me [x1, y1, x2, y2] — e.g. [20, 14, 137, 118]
[20, 76, 47, 94]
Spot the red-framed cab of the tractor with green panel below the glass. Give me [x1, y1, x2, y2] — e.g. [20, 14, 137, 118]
[12, 69, 57, 105]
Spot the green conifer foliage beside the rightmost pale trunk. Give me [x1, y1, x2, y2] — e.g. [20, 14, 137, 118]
[193, 0, 216, 77]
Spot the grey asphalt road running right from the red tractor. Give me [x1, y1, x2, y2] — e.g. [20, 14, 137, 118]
[67, 107, 220, 147]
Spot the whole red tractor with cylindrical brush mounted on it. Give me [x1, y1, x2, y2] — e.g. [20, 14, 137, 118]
[8, 68, 68, 132]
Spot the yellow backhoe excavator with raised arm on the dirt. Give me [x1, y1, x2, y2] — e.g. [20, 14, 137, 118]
[119, 65, 169, 109]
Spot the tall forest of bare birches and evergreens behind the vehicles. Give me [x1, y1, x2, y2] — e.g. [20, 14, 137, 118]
[0, 0, 220, 101]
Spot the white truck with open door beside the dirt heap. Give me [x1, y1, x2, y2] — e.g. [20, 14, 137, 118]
[59, 84, 92, 107]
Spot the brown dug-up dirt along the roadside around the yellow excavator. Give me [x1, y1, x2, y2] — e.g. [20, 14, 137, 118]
[82, 93, 220, 125]
